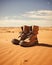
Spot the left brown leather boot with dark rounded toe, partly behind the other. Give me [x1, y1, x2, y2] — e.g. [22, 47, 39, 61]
[12, 25, 32, 45]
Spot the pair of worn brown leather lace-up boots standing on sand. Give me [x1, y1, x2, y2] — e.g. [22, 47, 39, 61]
[12, 25, 39, 47]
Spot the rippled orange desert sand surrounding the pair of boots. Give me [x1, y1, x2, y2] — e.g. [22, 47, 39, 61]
[0, 28, 52, 65]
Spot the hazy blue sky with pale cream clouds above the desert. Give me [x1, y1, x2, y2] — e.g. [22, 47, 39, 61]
[0, 0, 52, 26]
